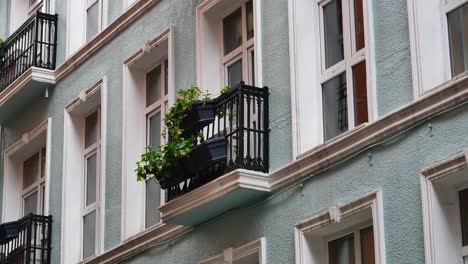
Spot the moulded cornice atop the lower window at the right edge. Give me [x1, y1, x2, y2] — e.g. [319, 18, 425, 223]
[421, 153, 468, 181]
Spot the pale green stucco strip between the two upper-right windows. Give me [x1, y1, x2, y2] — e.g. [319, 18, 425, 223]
[371, 0, 413, 116]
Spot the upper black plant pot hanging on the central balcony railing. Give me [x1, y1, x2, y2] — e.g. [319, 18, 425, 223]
[180, 100, 215, 136]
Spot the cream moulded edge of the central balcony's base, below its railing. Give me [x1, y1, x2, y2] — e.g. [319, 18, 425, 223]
[160, 169, 270, 222]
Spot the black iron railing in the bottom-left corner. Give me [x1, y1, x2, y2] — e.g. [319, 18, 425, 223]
[0, 214, 52, 264]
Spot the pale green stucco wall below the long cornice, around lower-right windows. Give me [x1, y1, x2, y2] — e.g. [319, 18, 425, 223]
[121, 102, 468, 264]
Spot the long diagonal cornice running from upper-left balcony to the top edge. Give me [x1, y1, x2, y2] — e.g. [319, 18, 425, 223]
[55, 0, 160, 81]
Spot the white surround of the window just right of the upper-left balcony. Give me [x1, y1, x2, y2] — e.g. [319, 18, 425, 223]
[65, 0, 108, 58]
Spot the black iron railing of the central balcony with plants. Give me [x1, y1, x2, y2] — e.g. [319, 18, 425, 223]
[166, 83, 269, 201]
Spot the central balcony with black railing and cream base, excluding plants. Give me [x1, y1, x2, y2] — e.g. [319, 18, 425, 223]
[161, 83, 269, 226]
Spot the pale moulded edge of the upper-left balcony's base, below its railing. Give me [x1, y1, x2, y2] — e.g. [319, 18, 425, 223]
[0, 67, 55, 107]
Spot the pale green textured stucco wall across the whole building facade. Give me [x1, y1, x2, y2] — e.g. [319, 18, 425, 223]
[0, 0, 462, 264]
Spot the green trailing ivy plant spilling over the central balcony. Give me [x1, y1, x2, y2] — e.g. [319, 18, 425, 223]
[135, 86, 210, 183]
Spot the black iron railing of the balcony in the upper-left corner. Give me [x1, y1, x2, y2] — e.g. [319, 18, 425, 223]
[0, 12, 57, 92]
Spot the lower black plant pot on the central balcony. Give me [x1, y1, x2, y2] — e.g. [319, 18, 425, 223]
[183, 137, 227, 173]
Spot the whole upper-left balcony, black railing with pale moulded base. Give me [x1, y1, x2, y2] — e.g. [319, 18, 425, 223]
[0, 12, 57, 121]
